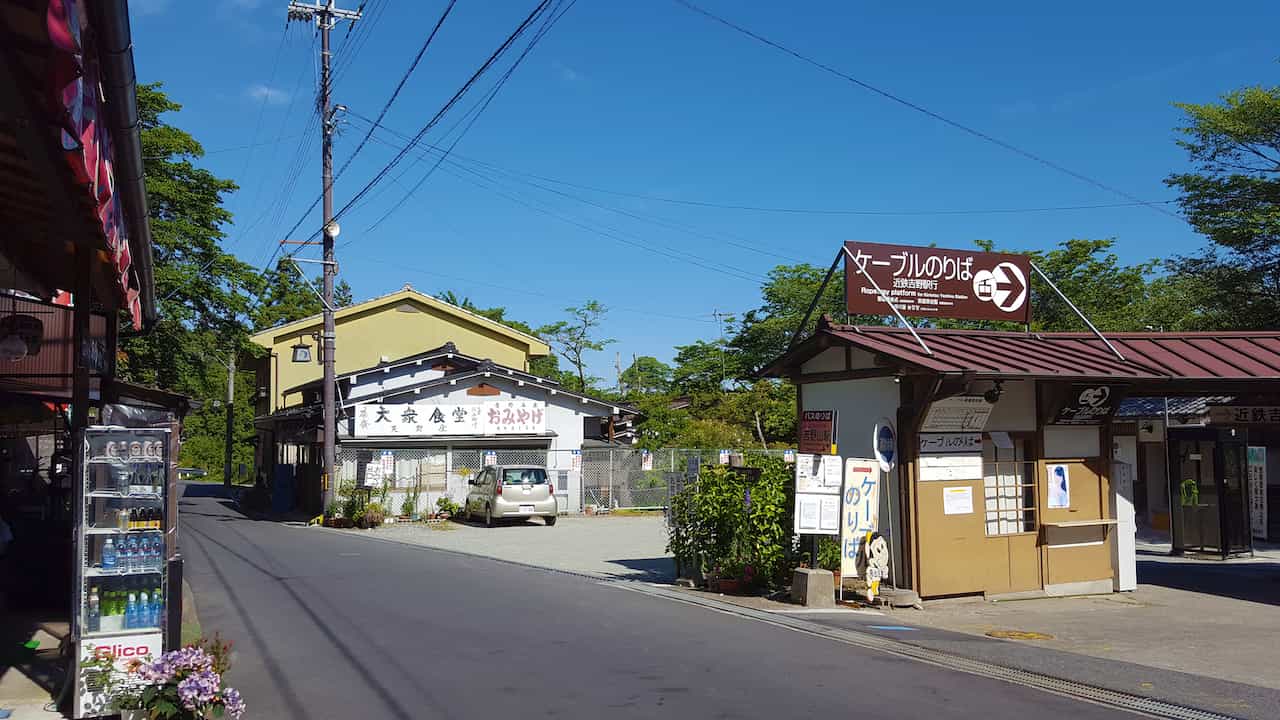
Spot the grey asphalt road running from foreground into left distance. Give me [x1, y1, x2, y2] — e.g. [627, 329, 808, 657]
[179, 486, 1132, 720]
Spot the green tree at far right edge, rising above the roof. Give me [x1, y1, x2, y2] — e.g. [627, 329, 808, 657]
[1165, 87, 1280, 329]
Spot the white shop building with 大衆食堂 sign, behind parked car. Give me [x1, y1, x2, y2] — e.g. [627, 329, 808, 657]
[257, 342, 636, 512]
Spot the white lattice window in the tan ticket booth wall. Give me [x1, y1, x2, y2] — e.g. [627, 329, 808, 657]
[982, 433, 1036, 536]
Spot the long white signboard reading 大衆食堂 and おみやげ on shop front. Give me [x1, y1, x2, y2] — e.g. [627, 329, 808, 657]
[356, 400, 547, 437]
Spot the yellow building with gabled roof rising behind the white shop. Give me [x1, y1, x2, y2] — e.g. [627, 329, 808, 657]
[251, 284, 550, 415]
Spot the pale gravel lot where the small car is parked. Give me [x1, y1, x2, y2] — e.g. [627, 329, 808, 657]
[339, 515, 676, 582]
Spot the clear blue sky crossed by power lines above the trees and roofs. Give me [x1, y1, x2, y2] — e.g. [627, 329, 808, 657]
[131, 0, 1280, 378]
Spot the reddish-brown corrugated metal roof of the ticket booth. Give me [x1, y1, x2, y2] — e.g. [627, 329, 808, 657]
[782, 324, 1280, 380]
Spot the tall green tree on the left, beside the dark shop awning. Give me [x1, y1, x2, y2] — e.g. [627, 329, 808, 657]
[119, 83, 262, 474]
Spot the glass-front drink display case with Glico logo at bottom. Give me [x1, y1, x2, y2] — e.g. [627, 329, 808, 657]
[73, 427, 172, 717]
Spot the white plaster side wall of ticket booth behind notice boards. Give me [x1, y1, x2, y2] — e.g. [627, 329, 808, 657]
[801, 376, 902, 580]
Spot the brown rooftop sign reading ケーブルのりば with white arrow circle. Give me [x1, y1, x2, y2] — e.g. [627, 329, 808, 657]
[845, 242, 1032, 323]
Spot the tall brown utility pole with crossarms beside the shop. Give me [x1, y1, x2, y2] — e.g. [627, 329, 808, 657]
[289, 0, 360, 507]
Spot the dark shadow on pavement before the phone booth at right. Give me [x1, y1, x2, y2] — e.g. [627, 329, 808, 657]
[1138, 557, 1280, 605]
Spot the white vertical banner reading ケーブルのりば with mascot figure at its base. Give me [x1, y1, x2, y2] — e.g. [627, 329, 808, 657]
[840, 457, 888, 600]
